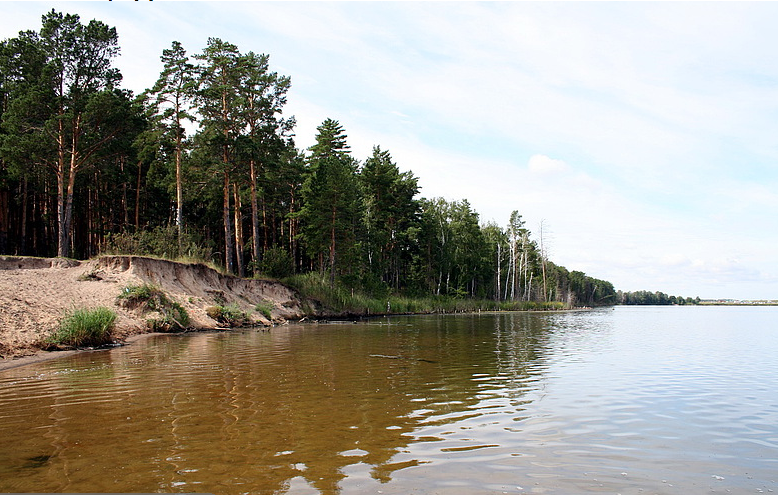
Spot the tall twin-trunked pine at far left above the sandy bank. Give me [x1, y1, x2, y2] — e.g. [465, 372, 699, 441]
[4, 10, 124, 256]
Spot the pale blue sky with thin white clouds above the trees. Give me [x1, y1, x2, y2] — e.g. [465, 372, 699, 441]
[0, 1, 778, 299]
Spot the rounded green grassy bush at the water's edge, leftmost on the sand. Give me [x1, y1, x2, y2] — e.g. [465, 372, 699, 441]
[47, 307, 116, 347]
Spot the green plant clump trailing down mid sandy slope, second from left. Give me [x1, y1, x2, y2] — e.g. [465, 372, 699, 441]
[117, 284, 190, 332]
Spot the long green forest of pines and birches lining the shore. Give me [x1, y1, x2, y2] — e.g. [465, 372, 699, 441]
[0, 10, 618, 305]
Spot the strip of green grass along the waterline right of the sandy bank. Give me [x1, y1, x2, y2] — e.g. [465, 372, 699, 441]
[283, 272, 565, 315]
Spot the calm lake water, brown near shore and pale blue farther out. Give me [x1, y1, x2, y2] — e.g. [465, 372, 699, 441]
[0, 306, 778, 494]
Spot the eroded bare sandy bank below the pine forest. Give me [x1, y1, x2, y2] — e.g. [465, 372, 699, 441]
[0, 256, 304, 369]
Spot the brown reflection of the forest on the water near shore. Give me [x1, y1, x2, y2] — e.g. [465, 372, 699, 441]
[0, 315, 544, 493]
